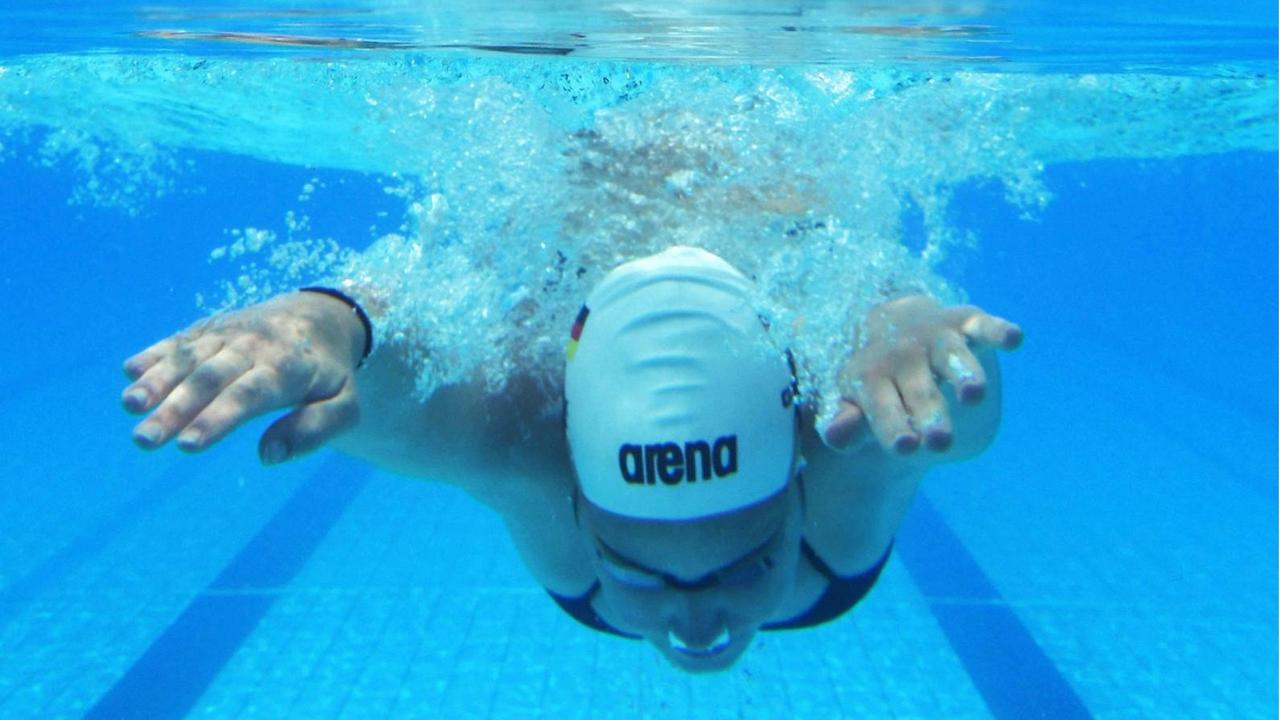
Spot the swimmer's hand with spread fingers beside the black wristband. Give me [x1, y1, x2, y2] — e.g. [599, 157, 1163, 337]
[123, 292, 365, 465]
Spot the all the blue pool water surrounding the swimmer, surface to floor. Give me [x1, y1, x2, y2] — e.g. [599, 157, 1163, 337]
[0, 1, 1277, 719]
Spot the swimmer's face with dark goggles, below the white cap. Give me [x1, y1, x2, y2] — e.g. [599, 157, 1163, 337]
[577, 468, 803, 673]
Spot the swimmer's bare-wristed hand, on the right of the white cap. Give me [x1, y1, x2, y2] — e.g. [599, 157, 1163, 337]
[823, 296, 1023, 455]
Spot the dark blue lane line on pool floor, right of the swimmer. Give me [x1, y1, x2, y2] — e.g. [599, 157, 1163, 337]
[895, 493, 1092, 720]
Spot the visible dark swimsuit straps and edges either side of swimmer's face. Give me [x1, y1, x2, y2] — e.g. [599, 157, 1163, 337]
[547, 539, 893, 639]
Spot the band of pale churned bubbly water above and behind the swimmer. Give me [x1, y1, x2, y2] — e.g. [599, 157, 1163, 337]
[0, 54, 1259, 420]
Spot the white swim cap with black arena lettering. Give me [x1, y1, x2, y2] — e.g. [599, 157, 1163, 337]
[564, 246, 797, 520]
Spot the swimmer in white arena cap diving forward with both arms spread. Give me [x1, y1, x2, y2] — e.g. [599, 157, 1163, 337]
[123, 246, 1021, 673]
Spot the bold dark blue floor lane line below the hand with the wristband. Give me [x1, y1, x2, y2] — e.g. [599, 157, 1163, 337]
[84, 456, 371, 720]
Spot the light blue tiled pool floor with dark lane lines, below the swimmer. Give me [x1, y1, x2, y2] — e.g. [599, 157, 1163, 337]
[0, 327, 1276, 719]
